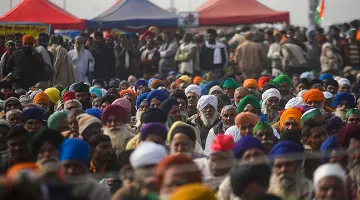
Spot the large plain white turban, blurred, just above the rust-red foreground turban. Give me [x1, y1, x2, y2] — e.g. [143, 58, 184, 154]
[130, 141, 168, 169]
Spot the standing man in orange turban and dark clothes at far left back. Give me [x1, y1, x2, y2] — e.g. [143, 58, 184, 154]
[6, 35, 45, 89]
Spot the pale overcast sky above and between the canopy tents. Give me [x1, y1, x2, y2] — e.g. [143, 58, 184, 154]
[0, 0, 360, 26]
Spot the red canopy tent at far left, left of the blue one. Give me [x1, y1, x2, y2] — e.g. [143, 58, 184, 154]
[0, 0, 85, 30]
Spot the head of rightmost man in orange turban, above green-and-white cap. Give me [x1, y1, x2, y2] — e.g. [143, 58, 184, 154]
[302, 89, 325, 111]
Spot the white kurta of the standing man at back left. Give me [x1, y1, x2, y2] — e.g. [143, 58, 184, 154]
[69, 49, 95, 83]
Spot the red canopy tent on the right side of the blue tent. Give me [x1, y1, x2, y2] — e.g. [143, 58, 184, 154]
[196, 0, 290, 26]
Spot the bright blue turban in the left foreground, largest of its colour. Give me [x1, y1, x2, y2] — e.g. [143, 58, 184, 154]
[59, 139, 90, 166]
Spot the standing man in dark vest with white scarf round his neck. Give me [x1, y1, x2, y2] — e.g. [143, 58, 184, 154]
[200, 29, 228, 78]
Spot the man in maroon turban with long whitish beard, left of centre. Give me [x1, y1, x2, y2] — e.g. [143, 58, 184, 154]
[101, 105, 134, 154]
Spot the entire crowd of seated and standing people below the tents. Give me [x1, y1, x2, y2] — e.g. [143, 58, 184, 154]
[0, 23, 360, 200]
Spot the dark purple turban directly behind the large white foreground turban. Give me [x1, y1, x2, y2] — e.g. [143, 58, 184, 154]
[140, 122, 168, 142]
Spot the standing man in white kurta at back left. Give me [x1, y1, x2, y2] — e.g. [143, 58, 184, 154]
[68, 36, 95, 83]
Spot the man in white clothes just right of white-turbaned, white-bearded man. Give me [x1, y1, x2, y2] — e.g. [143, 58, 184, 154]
[204, 105, 236, 155]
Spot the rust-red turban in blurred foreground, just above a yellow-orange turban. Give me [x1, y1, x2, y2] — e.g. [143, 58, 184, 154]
[155, 155, 202, 189]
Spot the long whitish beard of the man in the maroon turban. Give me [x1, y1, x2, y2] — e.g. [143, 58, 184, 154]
[104, 125, 133, 154]
